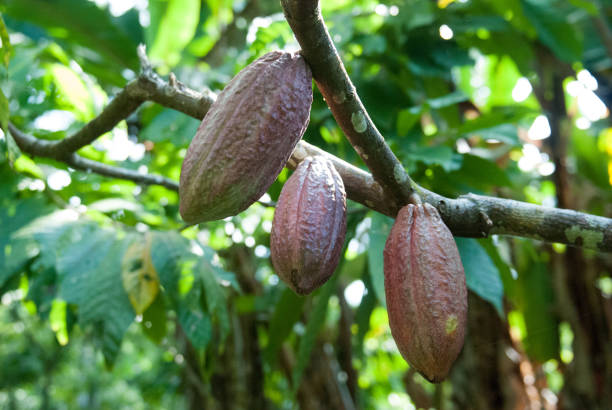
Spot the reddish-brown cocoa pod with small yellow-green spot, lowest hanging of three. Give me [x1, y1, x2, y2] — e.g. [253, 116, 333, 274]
[384, 203, 467, 383]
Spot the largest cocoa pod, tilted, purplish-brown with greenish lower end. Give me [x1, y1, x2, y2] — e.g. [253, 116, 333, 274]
[179, 51, 312, 223]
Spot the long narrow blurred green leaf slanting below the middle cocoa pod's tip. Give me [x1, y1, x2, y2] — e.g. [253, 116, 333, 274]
[291, 275, 339, 394]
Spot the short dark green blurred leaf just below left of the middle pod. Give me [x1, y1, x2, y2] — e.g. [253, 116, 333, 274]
[264, 288, 306, 366]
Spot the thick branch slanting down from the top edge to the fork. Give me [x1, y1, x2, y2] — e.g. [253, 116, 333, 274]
[281, 0, 413, 204]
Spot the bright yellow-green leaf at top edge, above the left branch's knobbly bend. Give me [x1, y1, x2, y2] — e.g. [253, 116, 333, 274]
[150, 0, 201, 67]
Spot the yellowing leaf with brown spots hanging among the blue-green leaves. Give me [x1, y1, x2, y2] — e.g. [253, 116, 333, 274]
[121, 234, 159, 315]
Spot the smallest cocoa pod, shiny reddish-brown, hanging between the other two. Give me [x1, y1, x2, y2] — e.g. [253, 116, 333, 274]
[270, 157, 346, 295]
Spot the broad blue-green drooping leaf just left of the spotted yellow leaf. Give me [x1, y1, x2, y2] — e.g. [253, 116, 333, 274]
[56, 229, 134, 364]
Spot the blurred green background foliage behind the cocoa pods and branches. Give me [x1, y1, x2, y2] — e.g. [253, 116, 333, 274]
[0, 0, 612, 409]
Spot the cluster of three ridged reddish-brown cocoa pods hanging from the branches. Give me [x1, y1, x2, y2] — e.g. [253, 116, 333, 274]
[179, 51, 467, 382]
